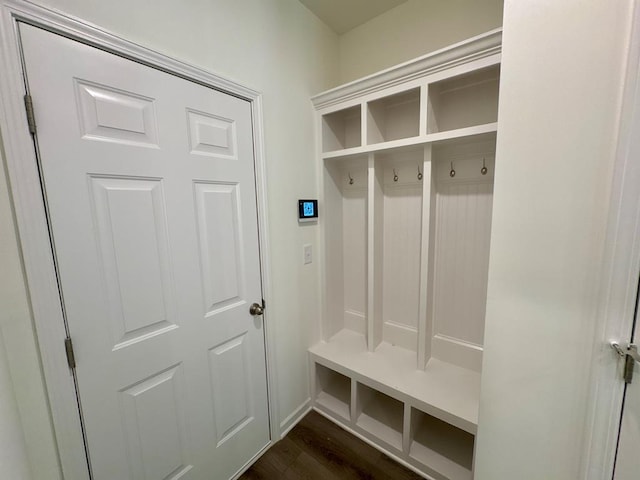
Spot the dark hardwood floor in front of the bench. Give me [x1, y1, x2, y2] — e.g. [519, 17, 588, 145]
[240, 412, 422, 480]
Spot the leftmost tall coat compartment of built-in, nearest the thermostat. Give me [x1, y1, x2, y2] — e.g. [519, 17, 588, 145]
[322, 157, 368, 341]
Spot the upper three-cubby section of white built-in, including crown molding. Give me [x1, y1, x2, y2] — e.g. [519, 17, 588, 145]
[312, 29, 502, 159]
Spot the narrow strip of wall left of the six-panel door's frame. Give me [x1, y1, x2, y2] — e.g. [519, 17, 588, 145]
[0, 136, 59, 480]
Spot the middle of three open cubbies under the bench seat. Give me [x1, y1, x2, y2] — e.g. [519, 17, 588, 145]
[356, 382, 404, 452]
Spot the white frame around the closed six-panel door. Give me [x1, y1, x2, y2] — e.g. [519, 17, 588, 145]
[0, 0, 280, 480]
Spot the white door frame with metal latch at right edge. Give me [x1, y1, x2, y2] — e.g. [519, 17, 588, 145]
[580, 0, 640, 480]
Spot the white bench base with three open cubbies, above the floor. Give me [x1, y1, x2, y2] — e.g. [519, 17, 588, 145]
[310, 346, 479, 480]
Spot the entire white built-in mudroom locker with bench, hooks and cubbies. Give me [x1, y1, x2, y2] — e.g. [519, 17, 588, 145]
[309, 30, 508, 480]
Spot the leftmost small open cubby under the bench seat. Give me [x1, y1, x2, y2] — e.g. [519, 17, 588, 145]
[315, 363, 351, 422]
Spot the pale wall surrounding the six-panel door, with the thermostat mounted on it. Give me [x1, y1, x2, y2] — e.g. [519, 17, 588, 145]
[0, 0, 338, 480]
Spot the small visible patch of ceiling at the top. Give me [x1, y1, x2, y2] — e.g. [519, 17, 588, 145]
[300, 0, 407, 34]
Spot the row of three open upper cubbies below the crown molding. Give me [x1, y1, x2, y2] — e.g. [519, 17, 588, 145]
[322, 74, 500, 159]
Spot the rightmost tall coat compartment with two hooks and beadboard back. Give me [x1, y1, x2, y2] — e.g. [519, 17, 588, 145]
[426, 134, 495, 372]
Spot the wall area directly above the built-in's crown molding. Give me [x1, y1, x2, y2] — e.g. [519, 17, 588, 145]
[340, 0, 503, 83]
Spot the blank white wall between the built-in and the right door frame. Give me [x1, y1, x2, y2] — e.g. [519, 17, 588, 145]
[475, 0, 633, 480]
